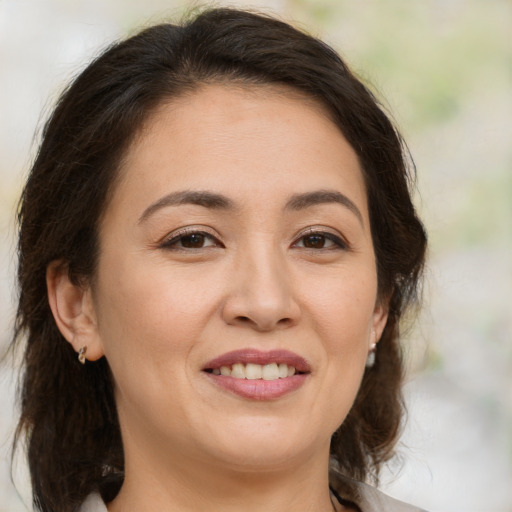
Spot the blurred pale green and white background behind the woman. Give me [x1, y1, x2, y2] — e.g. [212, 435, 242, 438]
[0, 0, 512, 512]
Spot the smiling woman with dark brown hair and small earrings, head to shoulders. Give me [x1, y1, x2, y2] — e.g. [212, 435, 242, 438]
[15, 9, 426, 512]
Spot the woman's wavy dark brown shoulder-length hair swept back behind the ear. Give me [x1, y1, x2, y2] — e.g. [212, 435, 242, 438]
[13, 9, 426, 512]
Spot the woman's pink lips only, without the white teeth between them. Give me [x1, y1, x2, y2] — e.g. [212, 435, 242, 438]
[203, 349, 311, 400]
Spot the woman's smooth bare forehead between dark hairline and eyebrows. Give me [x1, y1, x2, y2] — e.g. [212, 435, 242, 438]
[109, 84, 366, 221]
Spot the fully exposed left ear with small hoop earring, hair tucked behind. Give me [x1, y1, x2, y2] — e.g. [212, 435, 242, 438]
[46, 260, 104, 361]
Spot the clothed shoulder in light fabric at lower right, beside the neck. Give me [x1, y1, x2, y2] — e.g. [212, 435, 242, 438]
[330, 472, 426, 512]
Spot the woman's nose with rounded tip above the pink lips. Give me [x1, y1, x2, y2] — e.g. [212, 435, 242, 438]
[222, 245, 301, 332]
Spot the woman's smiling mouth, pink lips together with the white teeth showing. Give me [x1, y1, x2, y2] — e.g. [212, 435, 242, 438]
[203, 349, 311, 400]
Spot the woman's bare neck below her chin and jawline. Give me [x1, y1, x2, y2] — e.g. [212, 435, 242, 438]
[108, 440, 342, 512]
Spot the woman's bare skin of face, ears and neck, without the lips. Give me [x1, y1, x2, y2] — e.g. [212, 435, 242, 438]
[47, 85, 387, 512]
